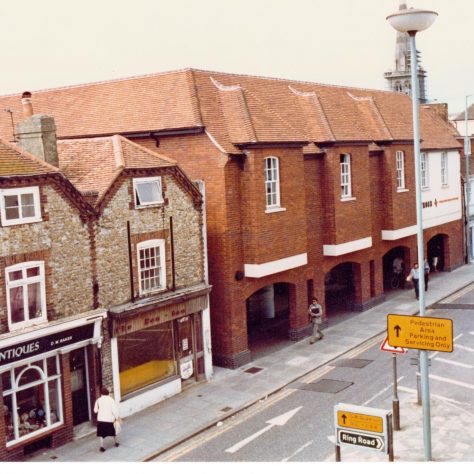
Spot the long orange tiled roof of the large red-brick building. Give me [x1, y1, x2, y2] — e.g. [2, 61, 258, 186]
[0, 69, 458, 153]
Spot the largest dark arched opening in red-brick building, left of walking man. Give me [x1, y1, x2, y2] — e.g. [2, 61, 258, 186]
[246, 283, 292, 355]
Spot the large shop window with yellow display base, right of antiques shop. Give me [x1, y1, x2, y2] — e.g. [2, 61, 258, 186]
[117, 322, 177, 397]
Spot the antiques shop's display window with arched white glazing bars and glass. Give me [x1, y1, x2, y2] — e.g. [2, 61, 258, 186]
[1, 356, 63, 446]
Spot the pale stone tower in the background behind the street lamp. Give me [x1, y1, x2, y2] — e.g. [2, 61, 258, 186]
[384, 0, 428, 104]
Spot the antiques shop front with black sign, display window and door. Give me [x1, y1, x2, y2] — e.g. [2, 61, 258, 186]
[0, 311, 106, 460]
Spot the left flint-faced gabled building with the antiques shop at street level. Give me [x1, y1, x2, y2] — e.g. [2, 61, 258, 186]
[0, 136, 106, 461]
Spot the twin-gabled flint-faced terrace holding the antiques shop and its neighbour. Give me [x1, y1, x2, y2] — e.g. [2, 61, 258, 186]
[0, 101, 212, 460]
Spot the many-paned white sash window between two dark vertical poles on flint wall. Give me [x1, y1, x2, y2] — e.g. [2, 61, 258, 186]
[137, 240, 166, 295]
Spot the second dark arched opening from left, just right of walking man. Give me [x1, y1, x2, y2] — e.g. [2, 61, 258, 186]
[324, 262, 355, 317]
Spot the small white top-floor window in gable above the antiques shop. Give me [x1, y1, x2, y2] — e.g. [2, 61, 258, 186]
[0, 187, 41, 226]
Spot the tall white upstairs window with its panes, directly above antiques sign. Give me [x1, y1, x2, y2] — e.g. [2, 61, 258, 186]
[5, 262, 46, 330]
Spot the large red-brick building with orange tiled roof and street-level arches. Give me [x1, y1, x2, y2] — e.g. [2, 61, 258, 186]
[0, 70, 463, 368]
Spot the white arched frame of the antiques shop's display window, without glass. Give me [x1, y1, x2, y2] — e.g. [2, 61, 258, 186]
[0, 354, 64, 447]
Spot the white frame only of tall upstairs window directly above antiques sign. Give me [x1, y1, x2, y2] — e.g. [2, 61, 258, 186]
[5, 261, 48, 331]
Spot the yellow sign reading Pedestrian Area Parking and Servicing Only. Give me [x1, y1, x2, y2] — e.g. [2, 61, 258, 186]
[387, 314, 453, 352]
